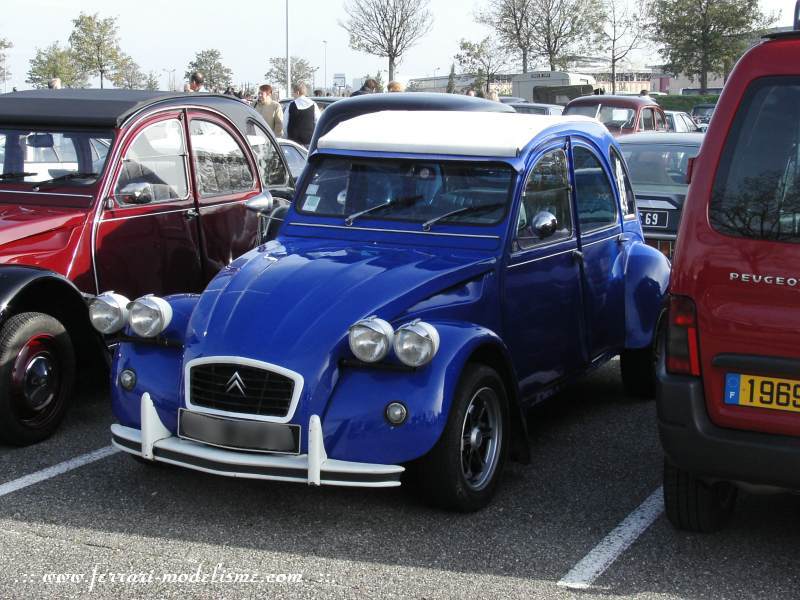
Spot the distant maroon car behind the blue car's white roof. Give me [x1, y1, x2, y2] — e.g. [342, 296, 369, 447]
[564, 95, 667, 136]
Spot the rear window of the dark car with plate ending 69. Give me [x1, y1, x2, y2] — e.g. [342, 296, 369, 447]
[622, 143, 700, 188]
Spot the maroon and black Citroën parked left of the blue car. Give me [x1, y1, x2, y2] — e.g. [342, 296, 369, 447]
[0, 90, 294, 444]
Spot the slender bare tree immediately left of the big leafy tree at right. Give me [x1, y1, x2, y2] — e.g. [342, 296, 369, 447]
[598, 0, 649, 94]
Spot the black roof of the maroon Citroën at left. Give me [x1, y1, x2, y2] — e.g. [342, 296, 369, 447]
[0, 89, 252, 128]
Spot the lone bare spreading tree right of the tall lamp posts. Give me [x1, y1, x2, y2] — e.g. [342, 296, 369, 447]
[339, 0, 433, 81]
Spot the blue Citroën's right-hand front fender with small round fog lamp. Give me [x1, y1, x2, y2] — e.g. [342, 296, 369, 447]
[322, 321, 513, 464]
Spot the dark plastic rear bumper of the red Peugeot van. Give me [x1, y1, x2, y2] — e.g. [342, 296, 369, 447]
[656, 368, 800, 490]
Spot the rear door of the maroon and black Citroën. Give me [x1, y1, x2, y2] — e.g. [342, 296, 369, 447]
[184, 111, 261, 279]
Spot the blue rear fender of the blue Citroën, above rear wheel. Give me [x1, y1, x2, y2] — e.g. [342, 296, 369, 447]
[625, 243, 670, 349]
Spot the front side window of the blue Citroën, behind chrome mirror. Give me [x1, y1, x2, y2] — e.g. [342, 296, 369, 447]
[517, 148, 572, 249]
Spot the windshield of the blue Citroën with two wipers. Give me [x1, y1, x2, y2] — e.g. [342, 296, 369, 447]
[298, 157, 515, 225]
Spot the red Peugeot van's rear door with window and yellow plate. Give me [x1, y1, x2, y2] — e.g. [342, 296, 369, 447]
[692, 76, 800, 435]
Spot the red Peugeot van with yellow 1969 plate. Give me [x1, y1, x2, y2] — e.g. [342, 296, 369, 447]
[657, 2, 800, 531]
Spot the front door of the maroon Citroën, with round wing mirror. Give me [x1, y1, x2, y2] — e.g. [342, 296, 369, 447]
[94, 111, 205, 299]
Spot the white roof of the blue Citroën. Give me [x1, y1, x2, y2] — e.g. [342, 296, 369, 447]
[318, 110, 607, 158]
